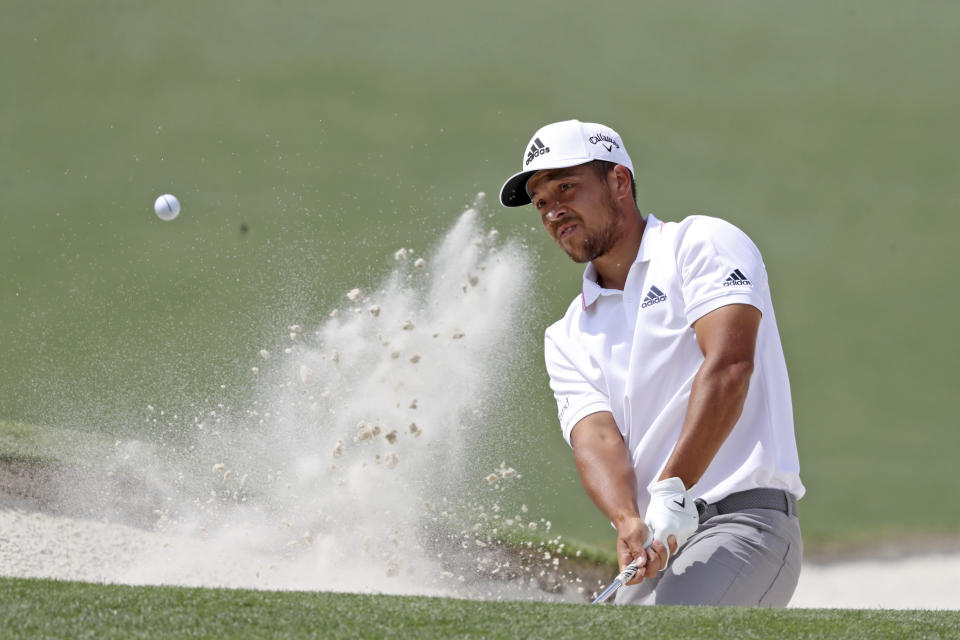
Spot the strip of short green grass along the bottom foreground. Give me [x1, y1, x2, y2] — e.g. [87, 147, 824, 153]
[0, 578, 960, 640]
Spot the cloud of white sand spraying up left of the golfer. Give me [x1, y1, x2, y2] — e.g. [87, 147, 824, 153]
[22, 194, 588, 598]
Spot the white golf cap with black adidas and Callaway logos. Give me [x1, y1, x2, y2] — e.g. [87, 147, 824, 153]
[500, 120, 634, 207]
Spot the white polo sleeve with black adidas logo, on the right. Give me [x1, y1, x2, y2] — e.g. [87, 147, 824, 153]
[677, 216, 767, 324]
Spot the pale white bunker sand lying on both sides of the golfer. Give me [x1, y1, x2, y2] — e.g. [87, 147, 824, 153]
[0, 509, 960, 609]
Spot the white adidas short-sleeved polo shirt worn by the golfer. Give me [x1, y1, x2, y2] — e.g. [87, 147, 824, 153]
[544, 215, 804, 513]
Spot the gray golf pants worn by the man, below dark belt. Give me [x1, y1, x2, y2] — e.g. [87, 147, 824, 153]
[616, 509, 803, 607]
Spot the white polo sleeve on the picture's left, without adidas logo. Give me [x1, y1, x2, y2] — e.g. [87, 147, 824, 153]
[544, 329, 610, 446]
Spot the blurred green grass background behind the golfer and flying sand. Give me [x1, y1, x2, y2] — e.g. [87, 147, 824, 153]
[0, 0, 960, 544]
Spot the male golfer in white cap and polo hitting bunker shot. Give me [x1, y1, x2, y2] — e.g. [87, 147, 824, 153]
[500, 120, 804, 607]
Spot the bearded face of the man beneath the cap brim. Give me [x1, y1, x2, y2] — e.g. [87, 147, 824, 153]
[527, 165, 620, 262]
